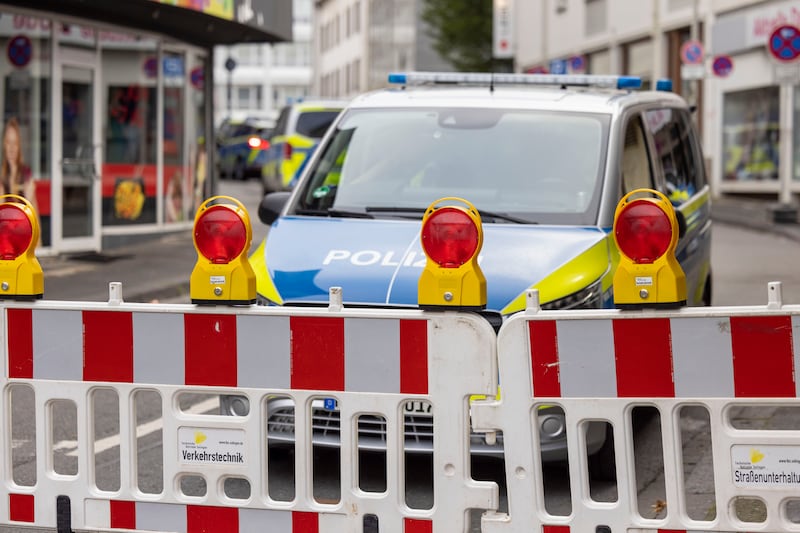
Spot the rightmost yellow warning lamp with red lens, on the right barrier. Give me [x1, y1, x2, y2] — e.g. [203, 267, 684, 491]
[613, 189, 686, 309]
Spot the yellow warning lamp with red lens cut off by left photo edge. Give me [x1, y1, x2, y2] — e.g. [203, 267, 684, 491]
[0, 194, 44, 300]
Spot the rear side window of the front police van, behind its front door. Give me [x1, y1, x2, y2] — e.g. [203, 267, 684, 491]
[645, 108, 705, 205]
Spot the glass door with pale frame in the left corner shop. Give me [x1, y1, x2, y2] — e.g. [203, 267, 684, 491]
[54, 49, 101, 251]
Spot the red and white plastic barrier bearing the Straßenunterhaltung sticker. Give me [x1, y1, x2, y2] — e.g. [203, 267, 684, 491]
[472, 290, 800, 533]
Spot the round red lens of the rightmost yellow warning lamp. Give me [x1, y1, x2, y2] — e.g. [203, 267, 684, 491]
[614, 200, 672, 264]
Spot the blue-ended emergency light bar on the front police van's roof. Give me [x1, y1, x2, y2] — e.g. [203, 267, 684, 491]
[389, 72, 642, 89]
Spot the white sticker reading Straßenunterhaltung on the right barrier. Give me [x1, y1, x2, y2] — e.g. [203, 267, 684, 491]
[731, 445, 800, 490]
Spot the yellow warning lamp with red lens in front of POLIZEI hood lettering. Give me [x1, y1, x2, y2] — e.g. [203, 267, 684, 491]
[417, 197, 486, 310]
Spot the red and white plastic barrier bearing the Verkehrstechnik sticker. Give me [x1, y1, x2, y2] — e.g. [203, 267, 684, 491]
[0, 301, 498, 533]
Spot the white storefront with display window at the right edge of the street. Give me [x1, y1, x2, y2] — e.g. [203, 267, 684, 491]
[706, 0, 800, 204]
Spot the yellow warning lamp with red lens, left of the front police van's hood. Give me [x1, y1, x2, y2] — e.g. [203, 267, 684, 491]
[189, 196, 256, 305]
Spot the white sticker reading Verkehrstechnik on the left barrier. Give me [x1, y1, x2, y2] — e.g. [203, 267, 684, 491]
[178, 427, 248, 465]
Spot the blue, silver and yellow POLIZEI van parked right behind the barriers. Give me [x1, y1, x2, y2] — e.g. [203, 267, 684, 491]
[245, 72, 711, 474]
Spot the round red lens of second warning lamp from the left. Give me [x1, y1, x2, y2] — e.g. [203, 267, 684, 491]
[194, 205, 247, 264]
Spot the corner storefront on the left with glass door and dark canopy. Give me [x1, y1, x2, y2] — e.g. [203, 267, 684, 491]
[0, 0, 292, 254]
